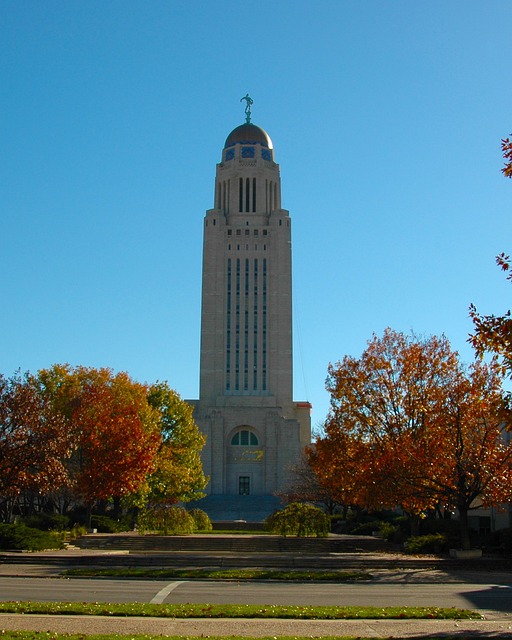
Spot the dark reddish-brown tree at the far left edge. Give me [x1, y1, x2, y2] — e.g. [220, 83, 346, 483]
[0, 374, 71, 520]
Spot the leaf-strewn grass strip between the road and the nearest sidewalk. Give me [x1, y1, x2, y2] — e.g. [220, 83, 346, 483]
[0, 602, 481, 620]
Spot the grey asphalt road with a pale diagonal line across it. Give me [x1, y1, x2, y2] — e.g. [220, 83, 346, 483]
[0, 576, 512, 613]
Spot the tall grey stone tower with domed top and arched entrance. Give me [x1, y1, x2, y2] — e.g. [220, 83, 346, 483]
[192, 109, 311, 519]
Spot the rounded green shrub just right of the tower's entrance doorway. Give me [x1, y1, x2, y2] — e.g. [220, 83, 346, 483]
[265, 502, 330, 538]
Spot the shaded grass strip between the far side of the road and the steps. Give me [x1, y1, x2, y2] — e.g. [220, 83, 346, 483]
[63, 567, 372, 582]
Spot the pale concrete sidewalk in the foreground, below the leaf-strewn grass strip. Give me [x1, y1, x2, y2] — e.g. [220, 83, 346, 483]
[0, 614, 512, 638]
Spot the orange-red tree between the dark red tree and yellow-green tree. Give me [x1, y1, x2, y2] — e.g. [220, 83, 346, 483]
[38, 365, 161, 515]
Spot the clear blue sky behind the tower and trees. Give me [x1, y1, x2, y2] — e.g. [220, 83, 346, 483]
[0, 0, 512, 426]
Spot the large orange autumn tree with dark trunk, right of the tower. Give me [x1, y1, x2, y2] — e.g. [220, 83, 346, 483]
[310, 329, 512, 548]
